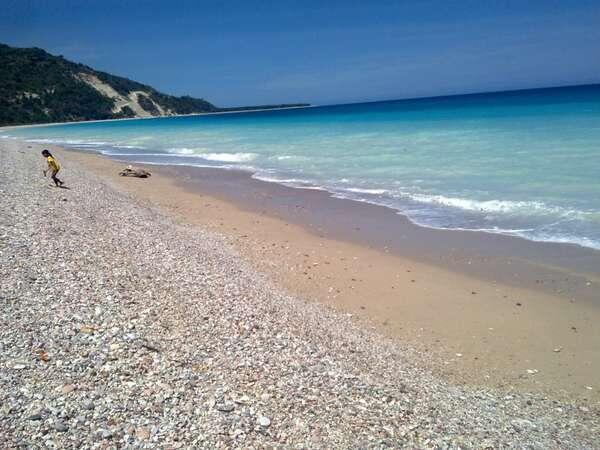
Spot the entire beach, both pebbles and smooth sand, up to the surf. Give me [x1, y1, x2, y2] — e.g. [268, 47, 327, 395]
[0, 140, 600, 448]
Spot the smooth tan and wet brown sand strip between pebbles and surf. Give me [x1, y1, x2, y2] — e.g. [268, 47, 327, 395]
[27, 139, 600, 403]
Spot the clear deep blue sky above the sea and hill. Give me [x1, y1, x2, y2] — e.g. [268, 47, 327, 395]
[0, 0, 600, 106]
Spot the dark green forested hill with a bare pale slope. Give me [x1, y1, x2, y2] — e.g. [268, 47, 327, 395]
[0, 44, 305, 125]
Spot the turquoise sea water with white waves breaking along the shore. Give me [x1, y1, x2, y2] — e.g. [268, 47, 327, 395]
[0, 85, 600, 249]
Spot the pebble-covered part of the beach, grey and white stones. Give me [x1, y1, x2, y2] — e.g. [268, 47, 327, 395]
[0, 140, 600, 449]
